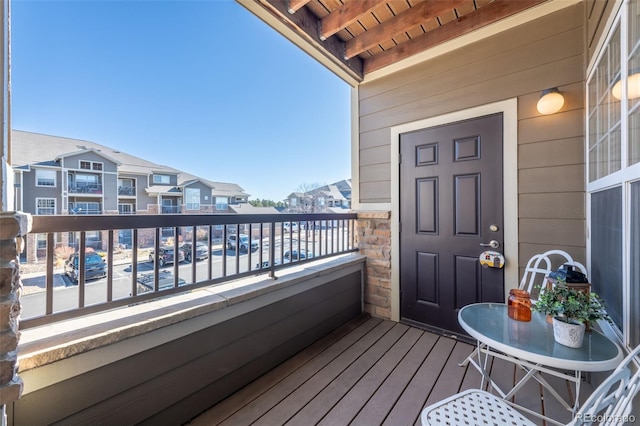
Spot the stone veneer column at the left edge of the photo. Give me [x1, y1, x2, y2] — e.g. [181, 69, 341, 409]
[0, 212, 31, 414]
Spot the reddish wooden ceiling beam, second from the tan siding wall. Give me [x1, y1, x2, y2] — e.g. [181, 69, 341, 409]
[345, 0, 468, 59]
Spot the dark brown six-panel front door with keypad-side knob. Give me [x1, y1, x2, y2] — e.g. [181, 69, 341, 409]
[400, 114, 504, 334]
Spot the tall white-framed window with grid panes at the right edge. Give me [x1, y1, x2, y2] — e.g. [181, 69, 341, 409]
[585, 0, 640, 346]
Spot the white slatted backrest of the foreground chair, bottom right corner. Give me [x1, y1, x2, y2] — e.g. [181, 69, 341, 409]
[569, 345, 640, 426]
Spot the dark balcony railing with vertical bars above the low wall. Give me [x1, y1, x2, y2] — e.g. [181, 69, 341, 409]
[20, 213, 357, 329]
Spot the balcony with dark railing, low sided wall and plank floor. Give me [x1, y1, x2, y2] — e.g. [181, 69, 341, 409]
[7, 214, 589, 425]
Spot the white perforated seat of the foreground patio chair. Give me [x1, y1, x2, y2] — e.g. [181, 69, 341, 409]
[420, 389, 535, 426]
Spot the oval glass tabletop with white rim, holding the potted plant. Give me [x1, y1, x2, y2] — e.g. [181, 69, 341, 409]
[458, 303, 623, 371]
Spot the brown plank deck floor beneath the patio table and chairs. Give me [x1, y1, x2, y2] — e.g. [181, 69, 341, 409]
[189, 316, 592, 426]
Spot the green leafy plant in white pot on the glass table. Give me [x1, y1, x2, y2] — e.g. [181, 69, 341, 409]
[531, 280, 611, 348]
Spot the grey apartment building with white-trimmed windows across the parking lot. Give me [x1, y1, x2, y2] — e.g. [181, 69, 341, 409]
[11, 130, 249, 260]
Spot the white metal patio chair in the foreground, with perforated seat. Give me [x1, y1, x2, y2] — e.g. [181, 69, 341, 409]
[420, 345, 640, 426]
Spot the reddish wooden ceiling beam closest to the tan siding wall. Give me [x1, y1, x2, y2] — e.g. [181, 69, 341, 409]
[363, 0, 547, 74]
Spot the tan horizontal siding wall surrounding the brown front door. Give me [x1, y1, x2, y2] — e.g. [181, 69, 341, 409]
[359, 3, 586, 265]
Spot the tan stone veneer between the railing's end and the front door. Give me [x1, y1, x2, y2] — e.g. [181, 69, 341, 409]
[356, 212, 391, 319]
